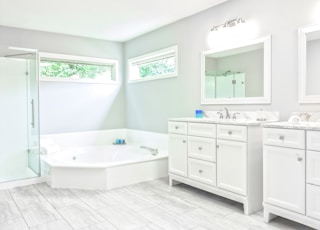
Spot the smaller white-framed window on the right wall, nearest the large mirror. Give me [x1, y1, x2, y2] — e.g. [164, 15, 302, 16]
[128, 46, 178, 83]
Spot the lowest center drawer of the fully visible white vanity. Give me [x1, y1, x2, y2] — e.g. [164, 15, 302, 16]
[188, 158, 217, 186]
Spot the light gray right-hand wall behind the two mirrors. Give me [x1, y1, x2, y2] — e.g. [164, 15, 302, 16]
[125, 0, 320, 133]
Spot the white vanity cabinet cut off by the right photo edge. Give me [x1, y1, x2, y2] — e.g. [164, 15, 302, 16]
[263, 125, 320, 229]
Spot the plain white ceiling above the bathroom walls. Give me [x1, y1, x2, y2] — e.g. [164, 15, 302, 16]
[0, 0, 227, 42]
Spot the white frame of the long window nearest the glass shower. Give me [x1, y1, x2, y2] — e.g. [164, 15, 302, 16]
[38, 52, 120, 85]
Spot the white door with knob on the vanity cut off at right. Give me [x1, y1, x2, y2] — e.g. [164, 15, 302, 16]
[263, 146, 305, 214]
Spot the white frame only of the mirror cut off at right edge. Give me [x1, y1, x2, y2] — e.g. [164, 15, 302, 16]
[298, 25, 320, 104]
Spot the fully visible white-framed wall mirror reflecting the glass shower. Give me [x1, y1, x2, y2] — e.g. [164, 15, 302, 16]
[201, 36, 271, 104]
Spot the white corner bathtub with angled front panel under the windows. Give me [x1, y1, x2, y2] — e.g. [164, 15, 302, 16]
[42, 145, 168, 189]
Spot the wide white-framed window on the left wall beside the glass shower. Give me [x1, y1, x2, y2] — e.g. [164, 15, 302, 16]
[39, 53, 118, 84]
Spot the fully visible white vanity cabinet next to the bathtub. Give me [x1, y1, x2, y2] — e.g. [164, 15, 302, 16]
[168, 119, 262, 214]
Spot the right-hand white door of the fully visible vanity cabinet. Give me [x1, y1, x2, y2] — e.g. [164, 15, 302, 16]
[217, 140, 247, 195]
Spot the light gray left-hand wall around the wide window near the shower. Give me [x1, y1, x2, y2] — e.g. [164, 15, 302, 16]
[0, 26, 126, 134]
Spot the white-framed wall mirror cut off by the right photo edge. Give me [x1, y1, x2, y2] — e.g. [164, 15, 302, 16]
[298, 25, 320, 103]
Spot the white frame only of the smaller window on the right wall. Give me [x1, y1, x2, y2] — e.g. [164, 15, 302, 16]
[128, 45, 178, 83]
